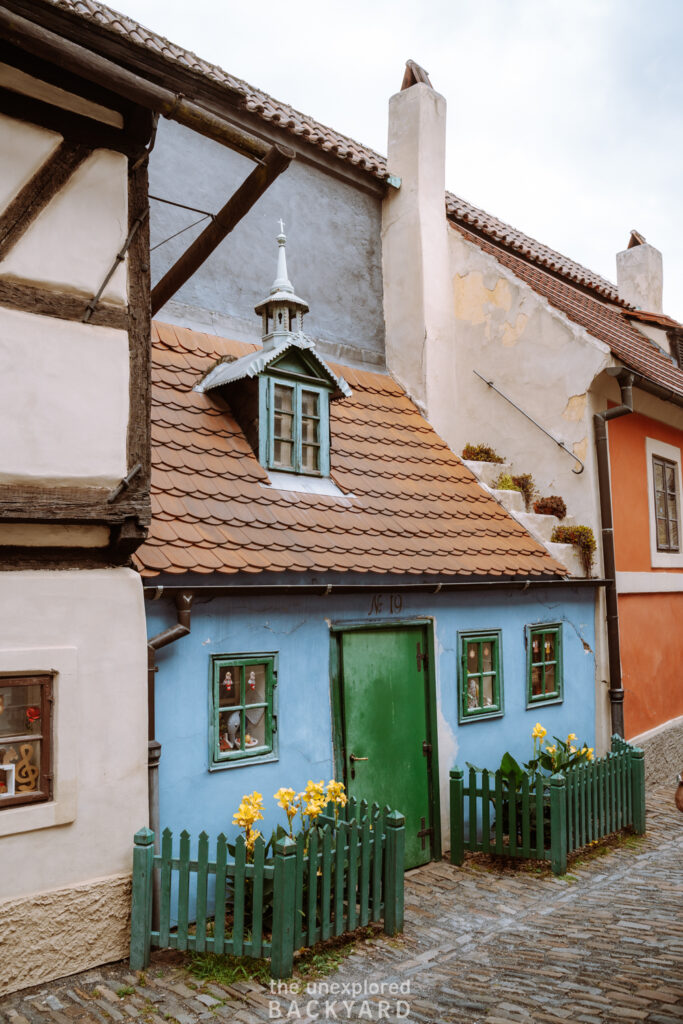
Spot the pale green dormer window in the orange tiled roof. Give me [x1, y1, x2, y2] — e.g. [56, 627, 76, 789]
[259, 376, 330, 476]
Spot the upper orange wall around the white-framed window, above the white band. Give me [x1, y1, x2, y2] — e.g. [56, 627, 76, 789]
[607, 413, 683, 572]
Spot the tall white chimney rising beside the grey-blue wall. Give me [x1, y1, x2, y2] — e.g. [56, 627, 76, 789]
[382, 61, 454, 430]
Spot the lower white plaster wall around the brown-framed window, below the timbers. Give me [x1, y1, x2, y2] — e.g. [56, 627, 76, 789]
[0, 568, 147, 901]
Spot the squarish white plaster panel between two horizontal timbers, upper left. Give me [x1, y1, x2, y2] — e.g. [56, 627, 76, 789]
[0, 308, 129, 486]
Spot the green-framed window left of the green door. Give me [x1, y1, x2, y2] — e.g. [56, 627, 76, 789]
[209, 653, 278, 770]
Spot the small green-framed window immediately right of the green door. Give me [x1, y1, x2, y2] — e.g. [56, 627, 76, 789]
[458, 630, 504, 724]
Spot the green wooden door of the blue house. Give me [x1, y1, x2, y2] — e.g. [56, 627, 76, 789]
[341, 627, 433, 867]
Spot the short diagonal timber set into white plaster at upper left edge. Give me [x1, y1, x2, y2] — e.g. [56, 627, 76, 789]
[0, 141, 90, 260]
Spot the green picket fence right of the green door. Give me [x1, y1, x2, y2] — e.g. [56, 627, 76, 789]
[451, 736, 645, 874]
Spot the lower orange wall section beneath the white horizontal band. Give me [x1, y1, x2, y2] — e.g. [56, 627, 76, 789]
[618, 593, 683, 738]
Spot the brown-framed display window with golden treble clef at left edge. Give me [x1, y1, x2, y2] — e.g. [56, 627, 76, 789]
[0, 676, 52, 810]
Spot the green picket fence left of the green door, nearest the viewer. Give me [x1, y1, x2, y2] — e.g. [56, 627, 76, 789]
[130, 801, 405, 978]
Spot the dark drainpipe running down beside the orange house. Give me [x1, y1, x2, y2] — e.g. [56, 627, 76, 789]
[593, 368, 634, 736]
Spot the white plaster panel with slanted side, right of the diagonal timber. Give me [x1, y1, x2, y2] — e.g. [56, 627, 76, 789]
[0, 147, 128, 304]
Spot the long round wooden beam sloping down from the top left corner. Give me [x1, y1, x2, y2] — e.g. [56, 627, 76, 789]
[0, 8, 270, 160]
